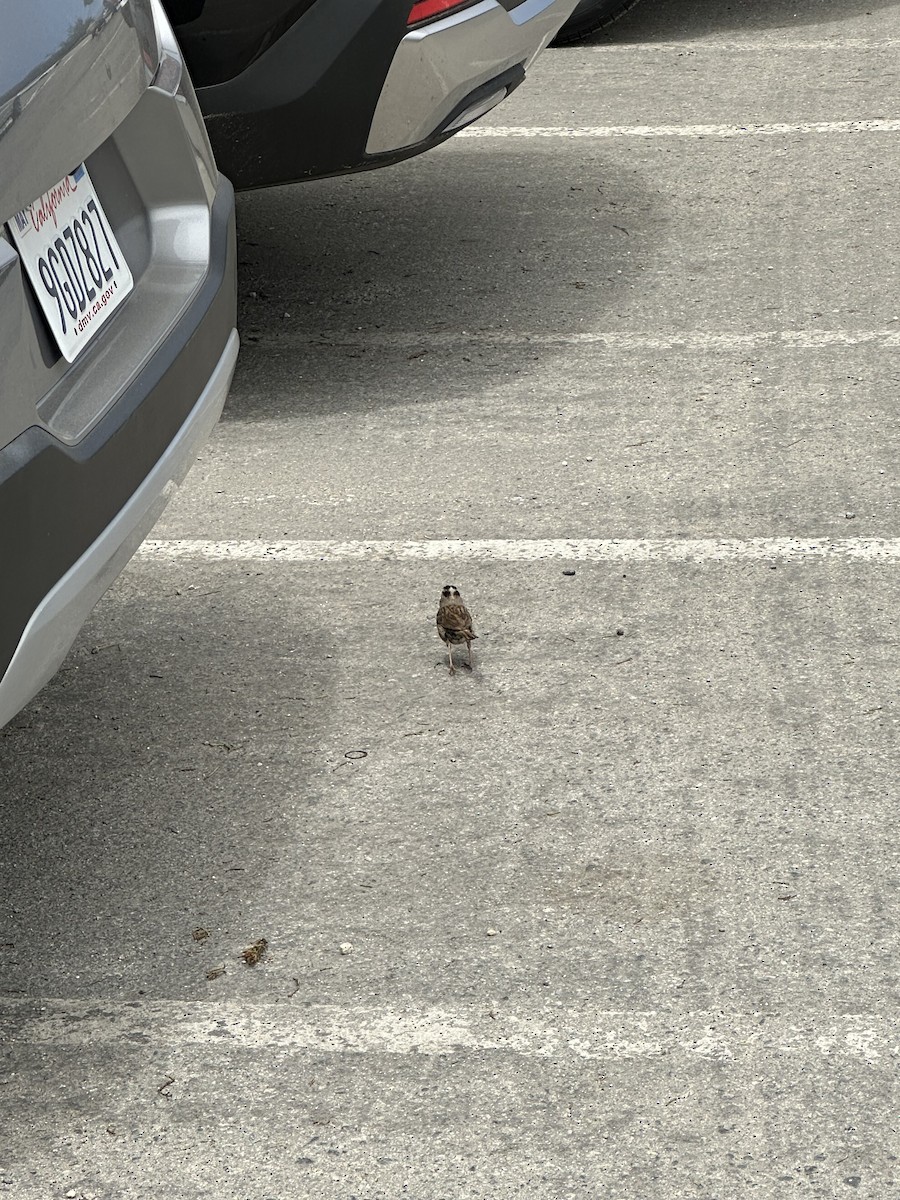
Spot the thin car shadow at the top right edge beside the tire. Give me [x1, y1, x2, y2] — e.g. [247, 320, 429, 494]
[581, 0, 900, 44]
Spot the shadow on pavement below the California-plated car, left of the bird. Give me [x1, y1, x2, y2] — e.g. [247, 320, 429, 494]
[0, 564, 332, 1000]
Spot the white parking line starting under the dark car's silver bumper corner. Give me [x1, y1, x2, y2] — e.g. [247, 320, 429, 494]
[460, 120, 900, 145]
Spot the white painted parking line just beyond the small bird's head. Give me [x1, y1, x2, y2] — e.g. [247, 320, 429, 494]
[137, 538, 900, 563]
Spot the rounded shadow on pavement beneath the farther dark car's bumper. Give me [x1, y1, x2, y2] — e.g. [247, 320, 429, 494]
[224, 139, 667, 421]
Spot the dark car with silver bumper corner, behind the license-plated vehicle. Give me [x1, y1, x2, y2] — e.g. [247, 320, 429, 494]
[166, 0, 575, 188]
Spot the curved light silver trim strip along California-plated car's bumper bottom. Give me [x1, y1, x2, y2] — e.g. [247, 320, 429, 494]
[0, 329, 239, 727]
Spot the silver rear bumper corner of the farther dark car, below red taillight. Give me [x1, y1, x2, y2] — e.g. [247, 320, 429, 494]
[366, 0, 574, 155]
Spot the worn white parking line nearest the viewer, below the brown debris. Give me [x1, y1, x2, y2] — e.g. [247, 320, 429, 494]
[0, 998, 900, 1067]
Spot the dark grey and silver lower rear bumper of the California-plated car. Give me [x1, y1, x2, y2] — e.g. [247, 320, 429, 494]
[0, 178, 238, 726]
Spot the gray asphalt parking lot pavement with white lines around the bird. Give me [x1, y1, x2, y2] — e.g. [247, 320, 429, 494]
[0, 0, 900, 1200]
